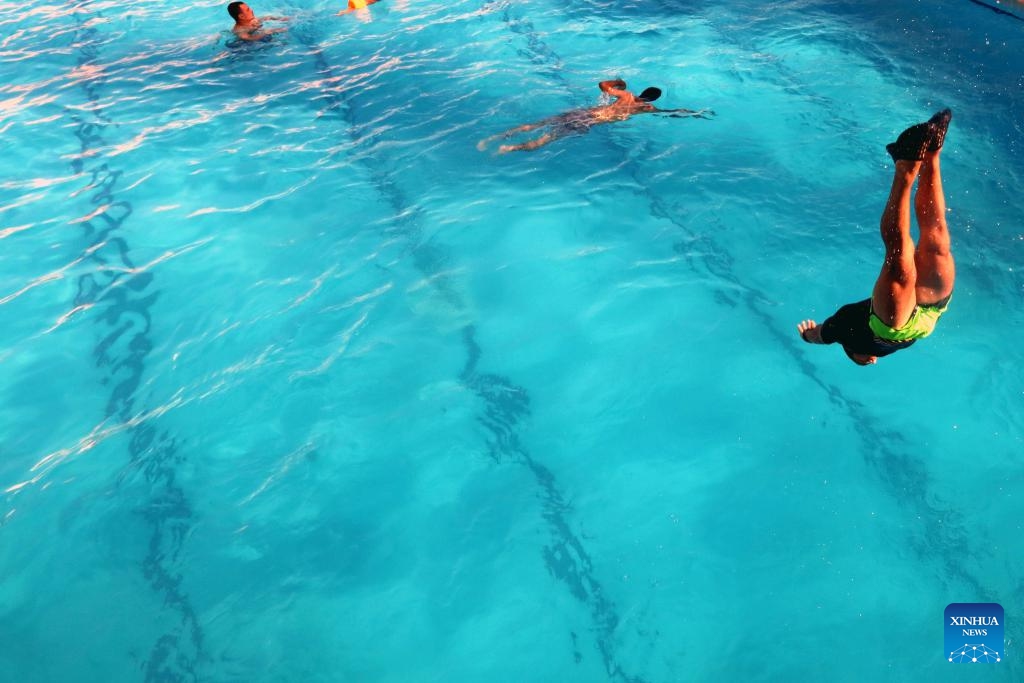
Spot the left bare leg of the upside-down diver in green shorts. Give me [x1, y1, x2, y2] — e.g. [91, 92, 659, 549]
[871, 161, 922, 328]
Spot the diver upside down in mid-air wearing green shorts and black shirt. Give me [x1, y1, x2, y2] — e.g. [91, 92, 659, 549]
[797, 110, 956, 366]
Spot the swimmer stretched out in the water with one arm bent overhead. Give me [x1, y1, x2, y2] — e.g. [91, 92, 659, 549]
[476, 79, 715, 154]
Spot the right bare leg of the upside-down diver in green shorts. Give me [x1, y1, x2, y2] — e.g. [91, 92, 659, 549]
[913, 152, 956, 304]
